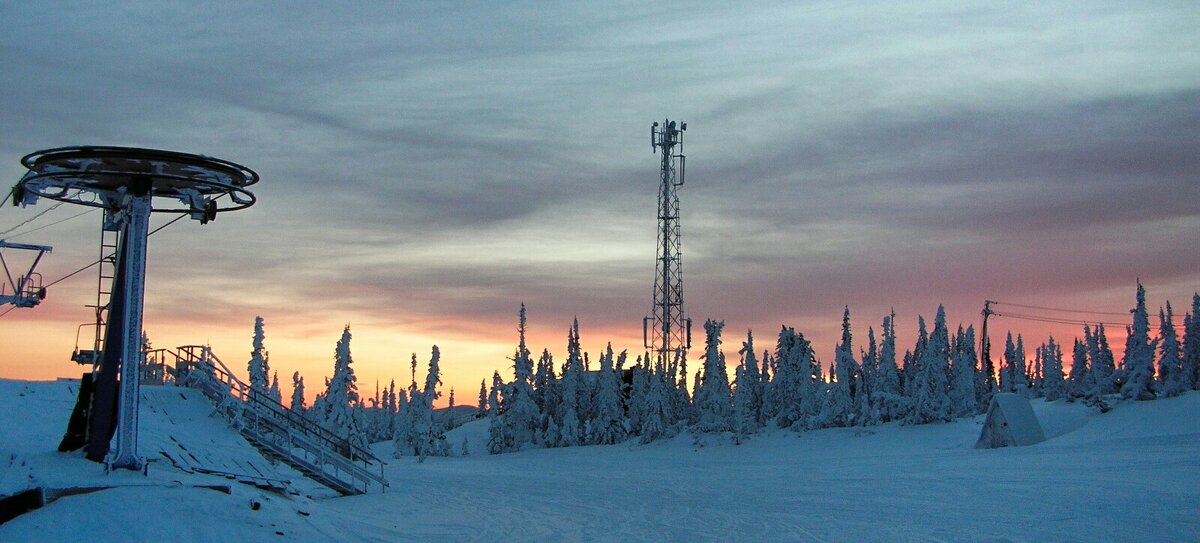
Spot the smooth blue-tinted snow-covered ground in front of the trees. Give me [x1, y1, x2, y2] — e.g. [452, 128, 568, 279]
[0, 381, 1200, 542]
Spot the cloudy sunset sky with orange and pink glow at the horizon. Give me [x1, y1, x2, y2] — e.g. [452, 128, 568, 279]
[0, 1, 1200, 404]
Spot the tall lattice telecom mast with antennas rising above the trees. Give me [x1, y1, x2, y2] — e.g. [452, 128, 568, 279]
[642, 119, 691, 363]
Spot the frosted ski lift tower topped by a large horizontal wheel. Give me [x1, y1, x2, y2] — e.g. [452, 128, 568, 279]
[13, 147, 258, 470]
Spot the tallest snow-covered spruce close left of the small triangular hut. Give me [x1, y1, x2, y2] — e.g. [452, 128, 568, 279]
[904, 305, 950, 424]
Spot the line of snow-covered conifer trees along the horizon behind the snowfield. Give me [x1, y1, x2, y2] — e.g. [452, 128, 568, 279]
[260, 282, 1200, 458]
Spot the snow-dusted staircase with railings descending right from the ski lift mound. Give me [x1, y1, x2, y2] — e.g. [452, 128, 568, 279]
[142, 345, 388, 495]
